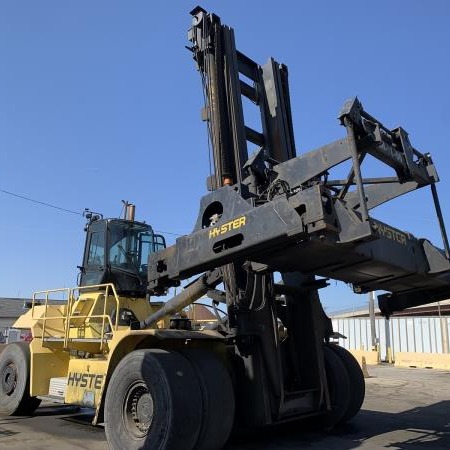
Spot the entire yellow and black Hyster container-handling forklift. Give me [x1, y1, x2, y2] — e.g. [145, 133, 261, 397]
[0, 7, 450, 450]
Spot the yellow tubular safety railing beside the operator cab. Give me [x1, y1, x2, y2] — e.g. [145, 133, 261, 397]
[31, 283, 120, 351]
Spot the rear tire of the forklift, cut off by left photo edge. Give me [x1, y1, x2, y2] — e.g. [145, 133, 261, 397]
[0, 342, 41, 416]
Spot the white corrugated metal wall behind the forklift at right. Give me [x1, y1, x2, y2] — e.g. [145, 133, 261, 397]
[333, 317, 450, 361]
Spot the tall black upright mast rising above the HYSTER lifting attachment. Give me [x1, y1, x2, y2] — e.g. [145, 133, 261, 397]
[189, 7, 296, 189]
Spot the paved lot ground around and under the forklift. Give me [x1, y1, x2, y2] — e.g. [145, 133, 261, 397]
[0, 365, 450, 450]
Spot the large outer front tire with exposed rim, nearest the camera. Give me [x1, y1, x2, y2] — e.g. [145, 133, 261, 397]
[105, 349, 202, 450]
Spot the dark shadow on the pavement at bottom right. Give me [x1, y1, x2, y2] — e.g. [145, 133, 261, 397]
[226, 401, 450, 450]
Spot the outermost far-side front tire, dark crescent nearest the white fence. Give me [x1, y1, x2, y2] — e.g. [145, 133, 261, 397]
[328, 344, 366, 422]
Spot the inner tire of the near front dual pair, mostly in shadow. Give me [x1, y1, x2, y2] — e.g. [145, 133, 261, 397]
[180, 349, 235, 450]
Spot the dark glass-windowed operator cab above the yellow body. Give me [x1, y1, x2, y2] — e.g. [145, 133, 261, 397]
[79, 209, 166, 297]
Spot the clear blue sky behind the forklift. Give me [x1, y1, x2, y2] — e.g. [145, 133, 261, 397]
[0, 0, 450, 310]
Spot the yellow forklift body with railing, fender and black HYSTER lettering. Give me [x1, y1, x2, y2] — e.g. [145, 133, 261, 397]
[13, 284, 225, 424]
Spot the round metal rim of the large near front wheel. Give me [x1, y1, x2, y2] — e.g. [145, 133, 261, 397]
[122, 381, 154, 438]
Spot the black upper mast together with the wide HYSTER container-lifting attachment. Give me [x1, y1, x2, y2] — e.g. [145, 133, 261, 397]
[149, 9, 450, 315]
